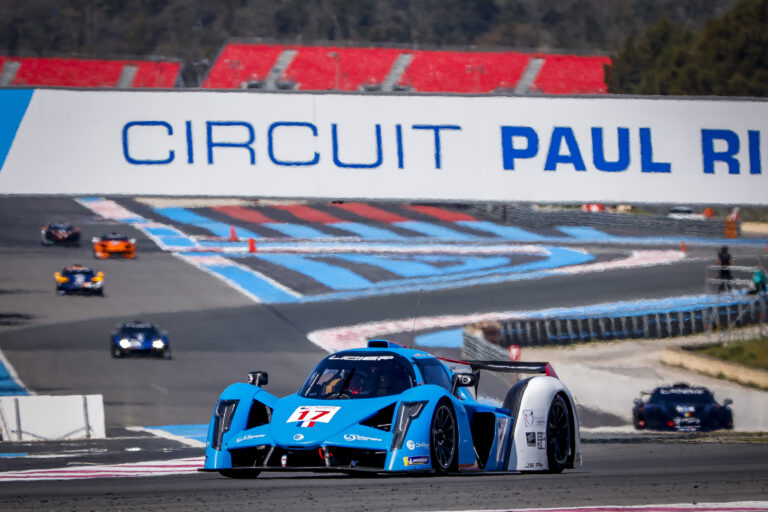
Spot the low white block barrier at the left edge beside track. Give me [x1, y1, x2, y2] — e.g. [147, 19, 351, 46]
[0, 395, 106, 441]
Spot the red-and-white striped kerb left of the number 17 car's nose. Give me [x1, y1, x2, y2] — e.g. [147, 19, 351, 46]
[0, 457, 204, 482]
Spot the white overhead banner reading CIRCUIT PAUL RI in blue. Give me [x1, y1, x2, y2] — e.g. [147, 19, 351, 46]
[0, 89, 768, 204]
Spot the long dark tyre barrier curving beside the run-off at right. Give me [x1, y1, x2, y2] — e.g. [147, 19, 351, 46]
[464, 295, 768, 350]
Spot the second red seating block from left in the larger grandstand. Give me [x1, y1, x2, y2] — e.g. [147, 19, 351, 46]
[281, 46, 401, 91]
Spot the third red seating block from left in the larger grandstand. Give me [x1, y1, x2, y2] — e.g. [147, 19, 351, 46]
[399, 51, 530, 93]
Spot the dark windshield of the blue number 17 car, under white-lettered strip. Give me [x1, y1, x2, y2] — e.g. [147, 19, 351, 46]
[299, 352, 416, 400]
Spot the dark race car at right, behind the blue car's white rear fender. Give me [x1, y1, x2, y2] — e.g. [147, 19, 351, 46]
[632, 382, 733, 432]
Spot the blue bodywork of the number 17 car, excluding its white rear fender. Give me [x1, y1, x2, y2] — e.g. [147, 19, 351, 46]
[204, 340, 512, 476]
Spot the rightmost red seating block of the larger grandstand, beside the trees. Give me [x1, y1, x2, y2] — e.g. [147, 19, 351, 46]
[531, 54, 611, 94]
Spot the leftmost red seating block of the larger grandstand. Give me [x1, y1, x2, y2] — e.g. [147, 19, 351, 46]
[203, 43, 286, 89]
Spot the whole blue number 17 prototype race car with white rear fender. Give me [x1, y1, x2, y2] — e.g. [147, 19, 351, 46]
[202, 340, 581, 478]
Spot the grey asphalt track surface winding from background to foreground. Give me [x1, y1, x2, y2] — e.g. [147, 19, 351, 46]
[0, 198, 768, 510]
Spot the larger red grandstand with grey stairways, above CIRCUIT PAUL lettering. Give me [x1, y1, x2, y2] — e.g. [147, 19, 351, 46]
[202, 43, 610, 94]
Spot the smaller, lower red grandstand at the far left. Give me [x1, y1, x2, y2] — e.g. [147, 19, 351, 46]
[0, 56, 181, 88]
